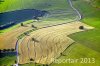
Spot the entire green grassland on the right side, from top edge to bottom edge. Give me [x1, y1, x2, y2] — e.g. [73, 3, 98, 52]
[51, 0, 100, 66]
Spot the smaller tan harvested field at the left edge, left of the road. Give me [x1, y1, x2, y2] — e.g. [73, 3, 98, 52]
[0, 26, 31, 49]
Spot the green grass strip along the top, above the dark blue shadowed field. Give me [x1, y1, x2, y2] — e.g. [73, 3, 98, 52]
[0, 0, 69, 12]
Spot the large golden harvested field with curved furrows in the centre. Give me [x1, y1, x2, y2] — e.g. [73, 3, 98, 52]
[18, 22, 93, 64]
